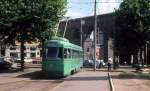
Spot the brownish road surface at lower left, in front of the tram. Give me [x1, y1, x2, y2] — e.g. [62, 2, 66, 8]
[0, 68, 62, 91]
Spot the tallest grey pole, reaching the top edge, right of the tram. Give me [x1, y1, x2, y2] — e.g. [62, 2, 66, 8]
[94, 0, 97, 71]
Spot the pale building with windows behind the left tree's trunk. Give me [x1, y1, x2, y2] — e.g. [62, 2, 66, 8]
[5, 42, 41, 61]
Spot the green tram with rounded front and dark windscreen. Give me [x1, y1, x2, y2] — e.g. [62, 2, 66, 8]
[42, 37, 83, 77]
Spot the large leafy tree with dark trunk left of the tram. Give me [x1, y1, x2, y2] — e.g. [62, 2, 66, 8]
[0, 0, 67, 70]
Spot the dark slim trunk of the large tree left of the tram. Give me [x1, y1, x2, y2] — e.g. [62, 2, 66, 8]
[20, 40, 24, 71]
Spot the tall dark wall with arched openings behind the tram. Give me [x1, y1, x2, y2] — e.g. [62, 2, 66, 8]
[59, 13, 115, 62]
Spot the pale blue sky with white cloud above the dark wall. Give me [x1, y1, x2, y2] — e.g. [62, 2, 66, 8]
[66, 0, 122, 18]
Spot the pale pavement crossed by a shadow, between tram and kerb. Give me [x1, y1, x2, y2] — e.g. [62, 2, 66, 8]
[50, 71, 110, 91]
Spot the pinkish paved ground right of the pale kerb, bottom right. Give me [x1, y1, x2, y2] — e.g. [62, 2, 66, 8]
[110, 67, 150, 91]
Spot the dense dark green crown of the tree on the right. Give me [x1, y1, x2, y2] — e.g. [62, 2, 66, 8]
[115, 0, 150, 64]
